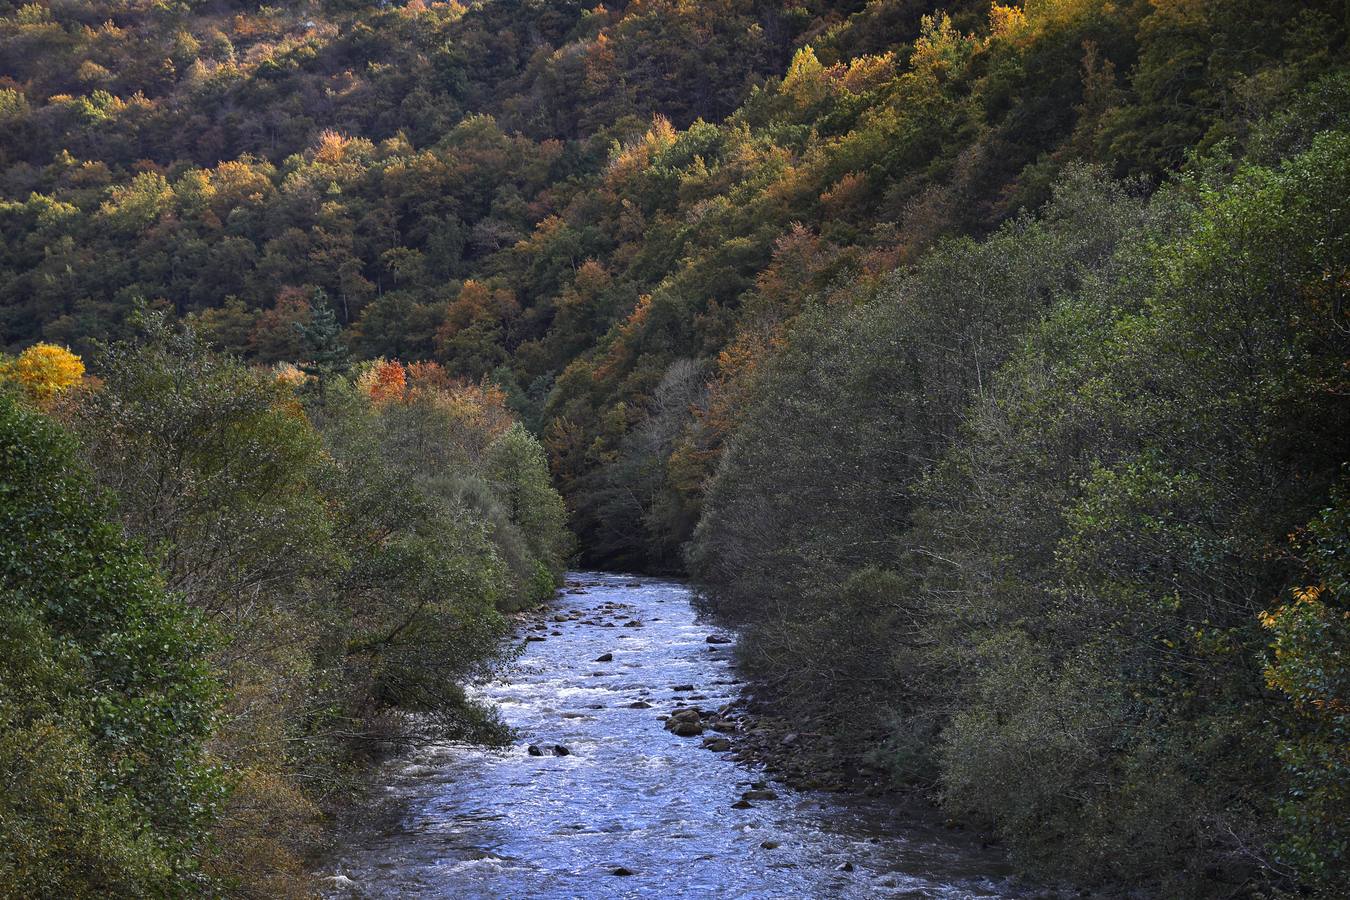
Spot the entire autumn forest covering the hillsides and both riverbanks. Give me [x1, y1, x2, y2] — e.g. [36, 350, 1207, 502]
[0, 0, 1350, 897]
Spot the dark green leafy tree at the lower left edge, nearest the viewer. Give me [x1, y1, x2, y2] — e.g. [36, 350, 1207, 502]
[0, 391, 216, 897]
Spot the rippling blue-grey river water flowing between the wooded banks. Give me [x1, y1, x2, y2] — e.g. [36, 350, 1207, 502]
[328, 572, 1018, 899]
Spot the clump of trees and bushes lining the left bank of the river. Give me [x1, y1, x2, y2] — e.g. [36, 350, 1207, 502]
[0, 318, 570, 897]
